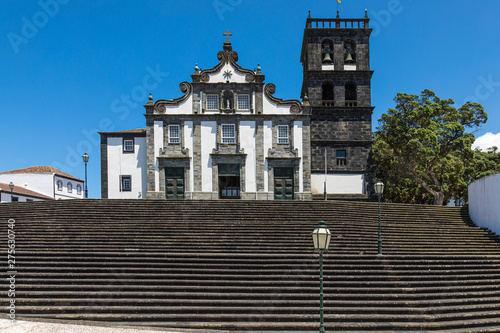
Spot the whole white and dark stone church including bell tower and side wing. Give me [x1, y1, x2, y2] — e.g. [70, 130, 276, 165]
[100, 11, 373, 200]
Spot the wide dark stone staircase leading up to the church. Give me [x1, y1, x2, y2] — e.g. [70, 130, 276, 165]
[0, 199, 500, 332]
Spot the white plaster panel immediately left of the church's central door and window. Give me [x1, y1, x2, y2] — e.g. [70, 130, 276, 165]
[200, 121, 217, 192]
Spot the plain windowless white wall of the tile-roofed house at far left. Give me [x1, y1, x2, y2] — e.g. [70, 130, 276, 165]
[0, 173, 54, 199]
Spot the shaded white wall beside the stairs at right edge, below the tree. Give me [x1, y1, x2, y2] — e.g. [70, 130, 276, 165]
[469, 173, 500, 234]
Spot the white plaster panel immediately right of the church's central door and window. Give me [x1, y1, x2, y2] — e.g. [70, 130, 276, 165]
[240, 121, 257, 192]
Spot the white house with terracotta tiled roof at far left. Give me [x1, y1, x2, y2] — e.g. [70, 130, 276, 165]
[0, 166, 84, 200]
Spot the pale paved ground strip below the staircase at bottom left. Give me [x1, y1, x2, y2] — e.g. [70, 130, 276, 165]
[0, 319, 230, 333]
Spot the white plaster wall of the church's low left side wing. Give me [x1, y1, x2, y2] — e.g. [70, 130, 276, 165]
[108, 137, 147, 199]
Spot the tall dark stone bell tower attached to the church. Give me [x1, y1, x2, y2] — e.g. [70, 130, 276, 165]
[301, 10, 374, 199]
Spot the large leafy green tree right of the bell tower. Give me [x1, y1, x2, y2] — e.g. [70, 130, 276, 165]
[373, 90, 487, 205]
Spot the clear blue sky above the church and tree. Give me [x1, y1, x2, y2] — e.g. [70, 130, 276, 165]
[0, 0, 500, 197]
